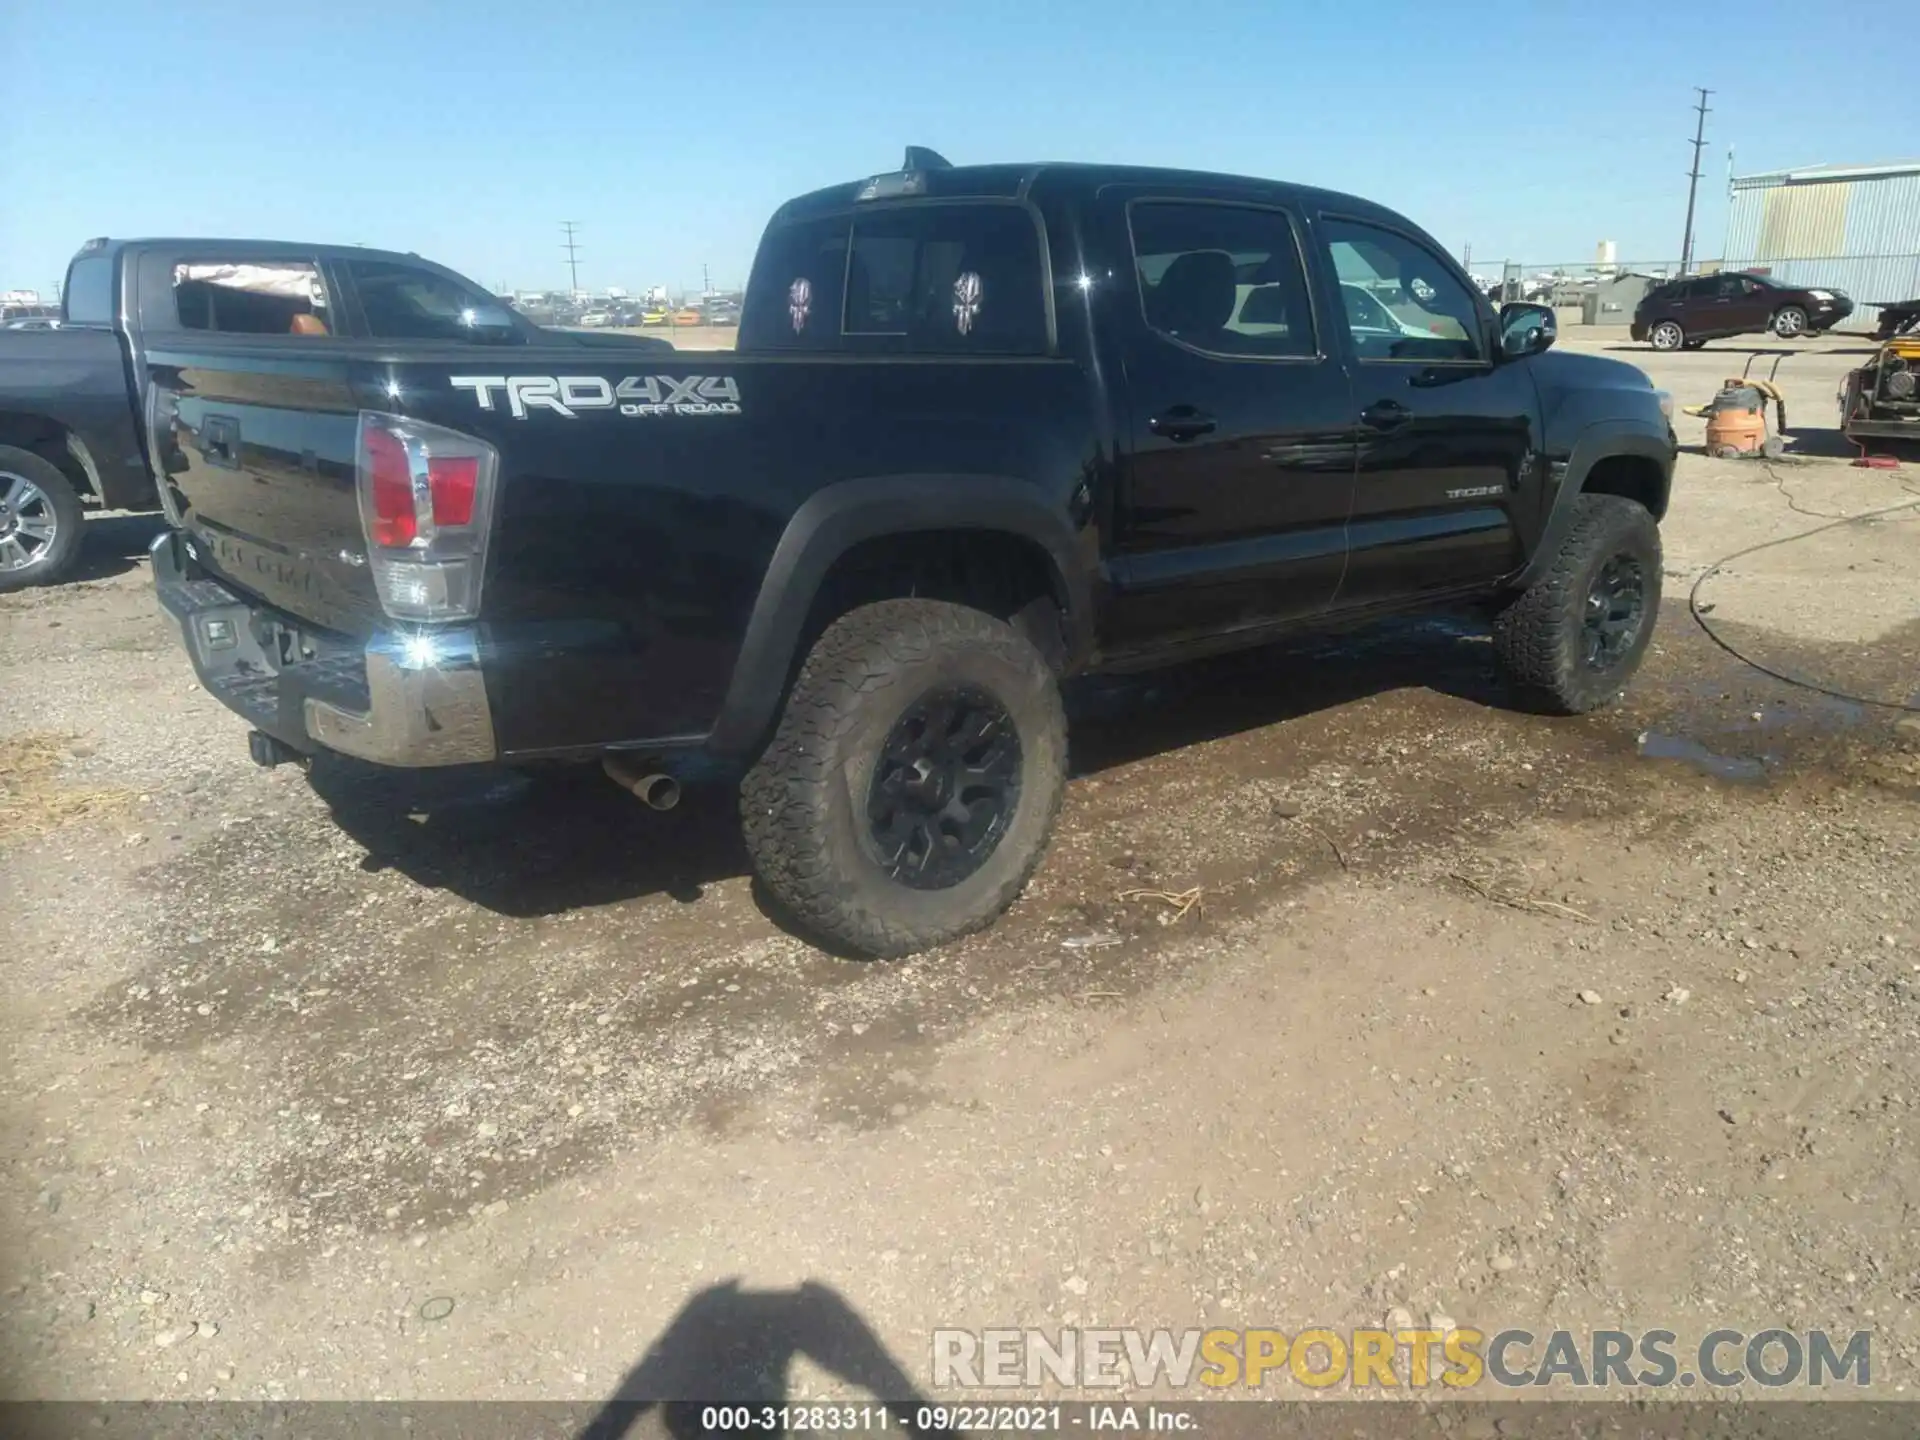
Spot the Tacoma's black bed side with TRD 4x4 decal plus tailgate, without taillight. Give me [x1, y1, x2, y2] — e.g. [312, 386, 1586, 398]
[146, 336, 1104, 756]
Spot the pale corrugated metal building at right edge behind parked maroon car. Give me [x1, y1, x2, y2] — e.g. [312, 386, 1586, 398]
[1722, 159, 1920, 330]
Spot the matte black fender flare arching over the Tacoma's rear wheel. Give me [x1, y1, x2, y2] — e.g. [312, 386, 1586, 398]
[707, 474, 1092, 756]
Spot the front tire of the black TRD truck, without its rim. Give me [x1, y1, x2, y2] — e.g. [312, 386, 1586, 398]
[1494, 495, 1661, 714]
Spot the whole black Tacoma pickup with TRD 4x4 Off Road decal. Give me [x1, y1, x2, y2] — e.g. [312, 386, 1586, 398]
[146, 150, 1674, 956]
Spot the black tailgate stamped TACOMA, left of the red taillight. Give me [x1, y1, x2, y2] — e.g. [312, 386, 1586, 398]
[146, 347, 380, 636]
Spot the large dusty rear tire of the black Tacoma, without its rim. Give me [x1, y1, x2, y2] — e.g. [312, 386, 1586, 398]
[739, 599, 1068, 960]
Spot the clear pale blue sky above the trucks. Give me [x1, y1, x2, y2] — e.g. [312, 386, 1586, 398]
[0, 0, 1889, 299]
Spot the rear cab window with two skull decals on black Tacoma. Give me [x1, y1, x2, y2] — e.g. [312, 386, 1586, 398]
[741, 205, 1046, 355]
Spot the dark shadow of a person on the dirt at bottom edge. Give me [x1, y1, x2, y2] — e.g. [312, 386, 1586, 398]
[578, 1281, 950, 1440]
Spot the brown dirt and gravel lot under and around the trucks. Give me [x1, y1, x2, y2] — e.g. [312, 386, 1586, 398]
[0, 332, 1920, 1398]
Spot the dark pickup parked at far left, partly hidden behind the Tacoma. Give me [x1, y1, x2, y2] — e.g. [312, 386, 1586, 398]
[0, 238, 668, 591]
